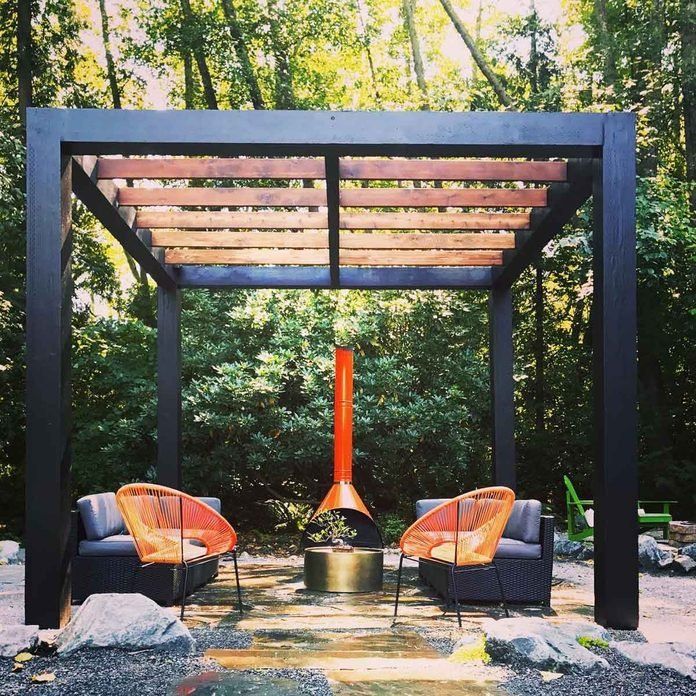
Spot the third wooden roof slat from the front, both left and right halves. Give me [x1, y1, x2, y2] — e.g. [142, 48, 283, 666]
[140, 210, 530, 230]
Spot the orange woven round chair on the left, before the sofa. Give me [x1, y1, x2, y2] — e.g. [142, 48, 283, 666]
[116, 483, 242, 619]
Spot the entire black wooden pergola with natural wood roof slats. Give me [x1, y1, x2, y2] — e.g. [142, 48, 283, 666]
[26, 109, 638, 629]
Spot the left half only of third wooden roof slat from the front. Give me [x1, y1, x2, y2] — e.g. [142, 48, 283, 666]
[135, 210, 327, 229]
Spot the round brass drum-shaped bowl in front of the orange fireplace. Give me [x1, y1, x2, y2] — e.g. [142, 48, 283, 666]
[304, 546, 384, 592]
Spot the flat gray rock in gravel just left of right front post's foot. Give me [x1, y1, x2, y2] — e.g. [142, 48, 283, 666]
[483, 618, 609, 673]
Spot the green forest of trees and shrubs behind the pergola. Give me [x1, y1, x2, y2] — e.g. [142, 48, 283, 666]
[0, 0, 696, 537]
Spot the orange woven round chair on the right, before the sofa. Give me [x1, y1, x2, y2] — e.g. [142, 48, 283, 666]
[394, 486, 515, 627]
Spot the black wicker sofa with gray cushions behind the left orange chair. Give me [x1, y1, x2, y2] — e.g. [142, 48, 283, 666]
[71, 493, 221, 606]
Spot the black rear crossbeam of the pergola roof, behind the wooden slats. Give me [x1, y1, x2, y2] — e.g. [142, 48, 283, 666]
[174, 266, 492, 290]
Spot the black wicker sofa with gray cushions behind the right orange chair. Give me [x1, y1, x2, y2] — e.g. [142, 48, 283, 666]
[416, 499, 553, 606]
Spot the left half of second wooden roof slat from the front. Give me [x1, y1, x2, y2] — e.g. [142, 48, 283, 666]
[118, 187, 326, 207]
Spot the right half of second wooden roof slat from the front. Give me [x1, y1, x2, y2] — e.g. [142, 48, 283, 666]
[341, 188, 548, 208]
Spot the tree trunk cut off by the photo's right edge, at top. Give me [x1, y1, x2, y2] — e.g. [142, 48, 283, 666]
[679, 0, 696, 216]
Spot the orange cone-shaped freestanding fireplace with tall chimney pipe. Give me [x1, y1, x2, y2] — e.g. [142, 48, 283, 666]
[303, 346, 382, 548]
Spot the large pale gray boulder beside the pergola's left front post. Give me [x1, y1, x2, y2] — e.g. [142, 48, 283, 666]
[56, 593, 194, 655]
